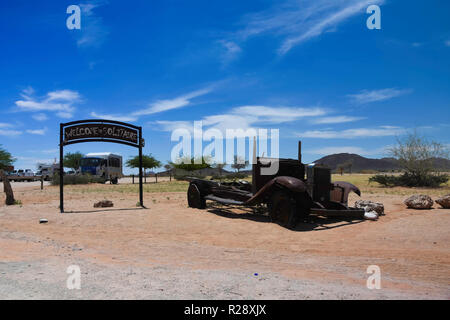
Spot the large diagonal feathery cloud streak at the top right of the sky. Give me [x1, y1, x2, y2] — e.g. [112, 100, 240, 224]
[232, 0, 384, 55]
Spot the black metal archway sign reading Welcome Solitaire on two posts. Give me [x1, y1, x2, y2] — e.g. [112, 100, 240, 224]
[59, 119, 145, 213]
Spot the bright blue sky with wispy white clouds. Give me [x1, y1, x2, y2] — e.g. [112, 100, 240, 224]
[0, 0, 450, 169]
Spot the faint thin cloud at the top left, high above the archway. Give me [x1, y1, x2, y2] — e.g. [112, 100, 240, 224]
[77, 1, 109, 47]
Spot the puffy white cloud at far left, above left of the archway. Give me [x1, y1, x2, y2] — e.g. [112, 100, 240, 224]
[15, 89, 81, 118]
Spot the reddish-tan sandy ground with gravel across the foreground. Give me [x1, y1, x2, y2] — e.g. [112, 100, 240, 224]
[0, 183, 450, 299]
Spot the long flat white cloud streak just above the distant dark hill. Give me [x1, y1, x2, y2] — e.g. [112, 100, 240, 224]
[296, 126, 406, 139]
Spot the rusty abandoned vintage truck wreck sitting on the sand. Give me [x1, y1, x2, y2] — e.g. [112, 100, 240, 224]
[187, 142, 364, 229]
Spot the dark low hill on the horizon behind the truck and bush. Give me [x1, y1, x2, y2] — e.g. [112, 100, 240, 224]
[314, 153, 450, 172]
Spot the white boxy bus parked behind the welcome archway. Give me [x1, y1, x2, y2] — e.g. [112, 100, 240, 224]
[80, 152, 123, 184]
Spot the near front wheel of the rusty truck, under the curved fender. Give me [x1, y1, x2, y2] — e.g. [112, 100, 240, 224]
[269, 190, 298, 229]
